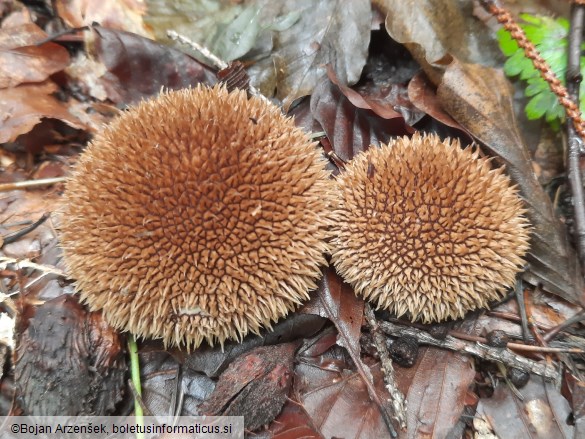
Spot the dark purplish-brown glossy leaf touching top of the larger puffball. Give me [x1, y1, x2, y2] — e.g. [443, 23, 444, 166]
[91, 27, 216, 104]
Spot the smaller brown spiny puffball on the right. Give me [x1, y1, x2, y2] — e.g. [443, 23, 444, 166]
[332, 134, 529, 323]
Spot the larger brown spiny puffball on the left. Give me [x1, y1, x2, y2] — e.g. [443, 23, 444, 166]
[58, 86, 333, 348]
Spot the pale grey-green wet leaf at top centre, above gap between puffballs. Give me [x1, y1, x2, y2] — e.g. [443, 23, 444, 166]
[251, 0, 372, 109]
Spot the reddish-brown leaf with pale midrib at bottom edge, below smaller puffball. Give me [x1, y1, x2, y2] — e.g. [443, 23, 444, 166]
[395, 348, 475, 438]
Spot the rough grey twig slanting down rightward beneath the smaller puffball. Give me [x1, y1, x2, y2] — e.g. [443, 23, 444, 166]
[379, 322, 561, 382]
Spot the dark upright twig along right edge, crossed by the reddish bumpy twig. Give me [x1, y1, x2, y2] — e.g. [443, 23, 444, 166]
[566, 3, 585, 271]
